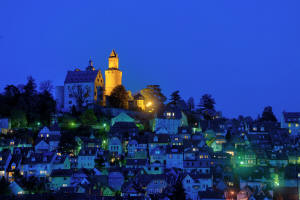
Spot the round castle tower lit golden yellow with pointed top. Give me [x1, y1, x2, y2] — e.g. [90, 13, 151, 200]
[105, 50, 122, 96]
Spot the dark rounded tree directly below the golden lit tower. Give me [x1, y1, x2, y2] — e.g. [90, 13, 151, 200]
[108, 85, 128, 109]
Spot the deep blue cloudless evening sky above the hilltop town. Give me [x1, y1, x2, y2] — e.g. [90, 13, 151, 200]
[0, 0, 300, 117]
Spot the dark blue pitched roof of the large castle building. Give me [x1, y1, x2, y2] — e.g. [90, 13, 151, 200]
[65, 70, 100, 84]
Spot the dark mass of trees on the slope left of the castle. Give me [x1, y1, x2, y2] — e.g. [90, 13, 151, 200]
[0, 76, 56, 128]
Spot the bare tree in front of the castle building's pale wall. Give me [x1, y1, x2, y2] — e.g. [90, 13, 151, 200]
[69, 85, 91, 110]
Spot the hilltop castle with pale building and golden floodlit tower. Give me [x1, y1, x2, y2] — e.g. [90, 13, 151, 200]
[55, 50, 145, 112]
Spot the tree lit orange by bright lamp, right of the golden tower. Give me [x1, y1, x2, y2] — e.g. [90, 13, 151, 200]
[141, 85, 167, 112]
